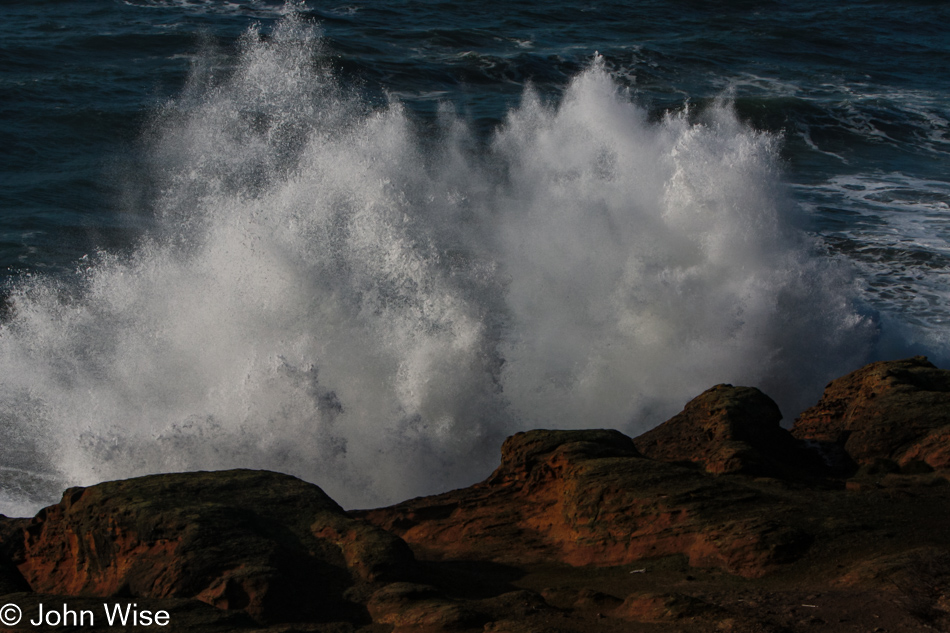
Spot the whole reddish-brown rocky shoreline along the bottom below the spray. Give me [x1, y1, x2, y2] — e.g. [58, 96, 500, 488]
[0, 357, 950, 633]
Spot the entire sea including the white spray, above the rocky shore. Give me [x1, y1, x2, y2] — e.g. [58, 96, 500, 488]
[0, 0, 950, 515]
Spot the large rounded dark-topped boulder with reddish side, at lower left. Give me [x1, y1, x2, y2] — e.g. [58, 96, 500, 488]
[13, 470, 413, 622]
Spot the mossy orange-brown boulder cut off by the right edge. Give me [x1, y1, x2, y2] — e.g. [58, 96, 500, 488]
[792, 356, 950, 472]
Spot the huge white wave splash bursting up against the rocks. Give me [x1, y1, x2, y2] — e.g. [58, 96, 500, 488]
[0, 15, 877, 512]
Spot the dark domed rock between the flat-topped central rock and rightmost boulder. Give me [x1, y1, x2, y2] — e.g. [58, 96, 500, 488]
[634, 385, 822, 477]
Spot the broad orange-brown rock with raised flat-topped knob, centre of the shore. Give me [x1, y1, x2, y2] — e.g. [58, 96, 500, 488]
[352, 430, 810, 577]
